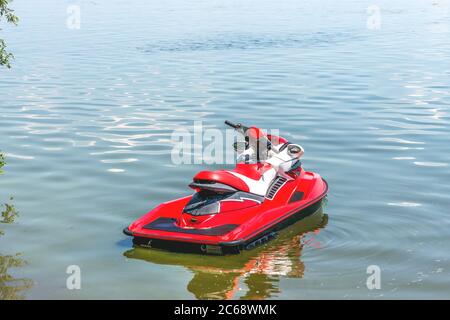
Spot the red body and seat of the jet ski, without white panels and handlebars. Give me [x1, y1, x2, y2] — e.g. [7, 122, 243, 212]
[124, 120, 328, 254]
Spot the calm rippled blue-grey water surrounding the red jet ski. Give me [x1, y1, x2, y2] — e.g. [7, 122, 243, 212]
[0, 0, 450, 299]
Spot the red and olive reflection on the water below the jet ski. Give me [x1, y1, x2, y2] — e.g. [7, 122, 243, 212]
[124, 207, 328, 299]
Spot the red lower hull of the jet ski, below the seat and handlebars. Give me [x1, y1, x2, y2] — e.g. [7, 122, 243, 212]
[124, 169, 328, 254]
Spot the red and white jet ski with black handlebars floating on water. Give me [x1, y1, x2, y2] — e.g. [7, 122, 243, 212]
[124, 121, 328, 254]
